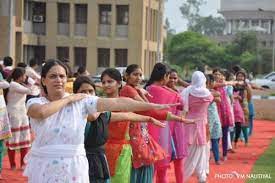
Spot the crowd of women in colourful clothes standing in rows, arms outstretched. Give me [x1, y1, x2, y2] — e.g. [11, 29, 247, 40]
[0, 57, 258, 183]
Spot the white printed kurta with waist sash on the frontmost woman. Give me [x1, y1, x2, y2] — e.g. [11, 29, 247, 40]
[24, 95, 98, 183]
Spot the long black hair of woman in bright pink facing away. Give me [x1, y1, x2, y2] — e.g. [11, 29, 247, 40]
[144, 63, 170, 88]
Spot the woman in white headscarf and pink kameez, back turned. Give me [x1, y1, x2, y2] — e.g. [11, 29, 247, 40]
[181, 71, 215, 182]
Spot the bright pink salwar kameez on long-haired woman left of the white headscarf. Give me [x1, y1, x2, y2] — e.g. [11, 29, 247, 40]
[147, 84, 186, 183]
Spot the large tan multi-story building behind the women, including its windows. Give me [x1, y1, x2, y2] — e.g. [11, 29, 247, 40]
[0, 0, 163, 76]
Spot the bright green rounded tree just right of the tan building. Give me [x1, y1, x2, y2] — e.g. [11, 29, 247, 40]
[168, 31, 224, 69]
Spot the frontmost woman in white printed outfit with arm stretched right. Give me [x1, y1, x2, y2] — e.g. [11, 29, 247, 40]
[24, 60, 175, 183]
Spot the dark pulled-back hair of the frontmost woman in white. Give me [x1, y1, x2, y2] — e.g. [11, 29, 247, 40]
[41, 59, 68, 94]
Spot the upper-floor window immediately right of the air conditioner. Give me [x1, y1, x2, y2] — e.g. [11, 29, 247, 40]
[57, 3, 70, 35]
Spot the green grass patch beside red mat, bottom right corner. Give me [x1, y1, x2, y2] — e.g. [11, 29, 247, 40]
[246, 139, 275, 183]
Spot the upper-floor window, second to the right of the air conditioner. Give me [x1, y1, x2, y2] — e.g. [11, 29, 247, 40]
[75, 4, 87, 36]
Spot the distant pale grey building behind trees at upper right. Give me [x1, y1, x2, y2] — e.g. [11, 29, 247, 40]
[215, 0, 275, 47]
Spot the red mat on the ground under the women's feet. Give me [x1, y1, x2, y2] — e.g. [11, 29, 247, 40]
[0, 120, 275, 183]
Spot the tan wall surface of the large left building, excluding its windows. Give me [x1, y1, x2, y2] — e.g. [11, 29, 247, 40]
[0, 0, 163, 76]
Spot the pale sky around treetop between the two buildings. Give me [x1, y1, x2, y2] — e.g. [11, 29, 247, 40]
[165, 0, 220, 33]
